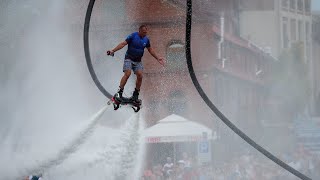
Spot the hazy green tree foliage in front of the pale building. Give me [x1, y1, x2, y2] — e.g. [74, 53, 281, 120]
[271, 43, 311, 115]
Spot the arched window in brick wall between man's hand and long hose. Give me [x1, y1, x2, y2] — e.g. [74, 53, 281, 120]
[167, 40, 187, 71]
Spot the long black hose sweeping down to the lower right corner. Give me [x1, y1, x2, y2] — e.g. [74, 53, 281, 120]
[186, 0, 311, 180]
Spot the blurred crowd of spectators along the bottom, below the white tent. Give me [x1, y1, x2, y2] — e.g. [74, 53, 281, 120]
[141, 152, 320, 180]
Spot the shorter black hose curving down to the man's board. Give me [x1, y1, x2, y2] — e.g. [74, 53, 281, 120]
[83, 0, 112, 99]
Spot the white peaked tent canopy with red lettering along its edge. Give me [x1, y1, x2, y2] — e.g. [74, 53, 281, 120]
[142, 114, 212, 143]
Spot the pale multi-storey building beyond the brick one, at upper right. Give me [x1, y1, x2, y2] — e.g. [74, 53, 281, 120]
[240, 0, 312, 61]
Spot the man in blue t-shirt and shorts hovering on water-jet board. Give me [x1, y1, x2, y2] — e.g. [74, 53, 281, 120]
[107, 25, 165, 101]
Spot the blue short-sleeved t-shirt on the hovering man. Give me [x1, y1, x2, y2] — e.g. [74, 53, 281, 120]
[125, 32, 150, 62]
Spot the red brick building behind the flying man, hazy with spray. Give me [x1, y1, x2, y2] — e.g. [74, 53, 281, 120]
[77, 0, 296, 163]
